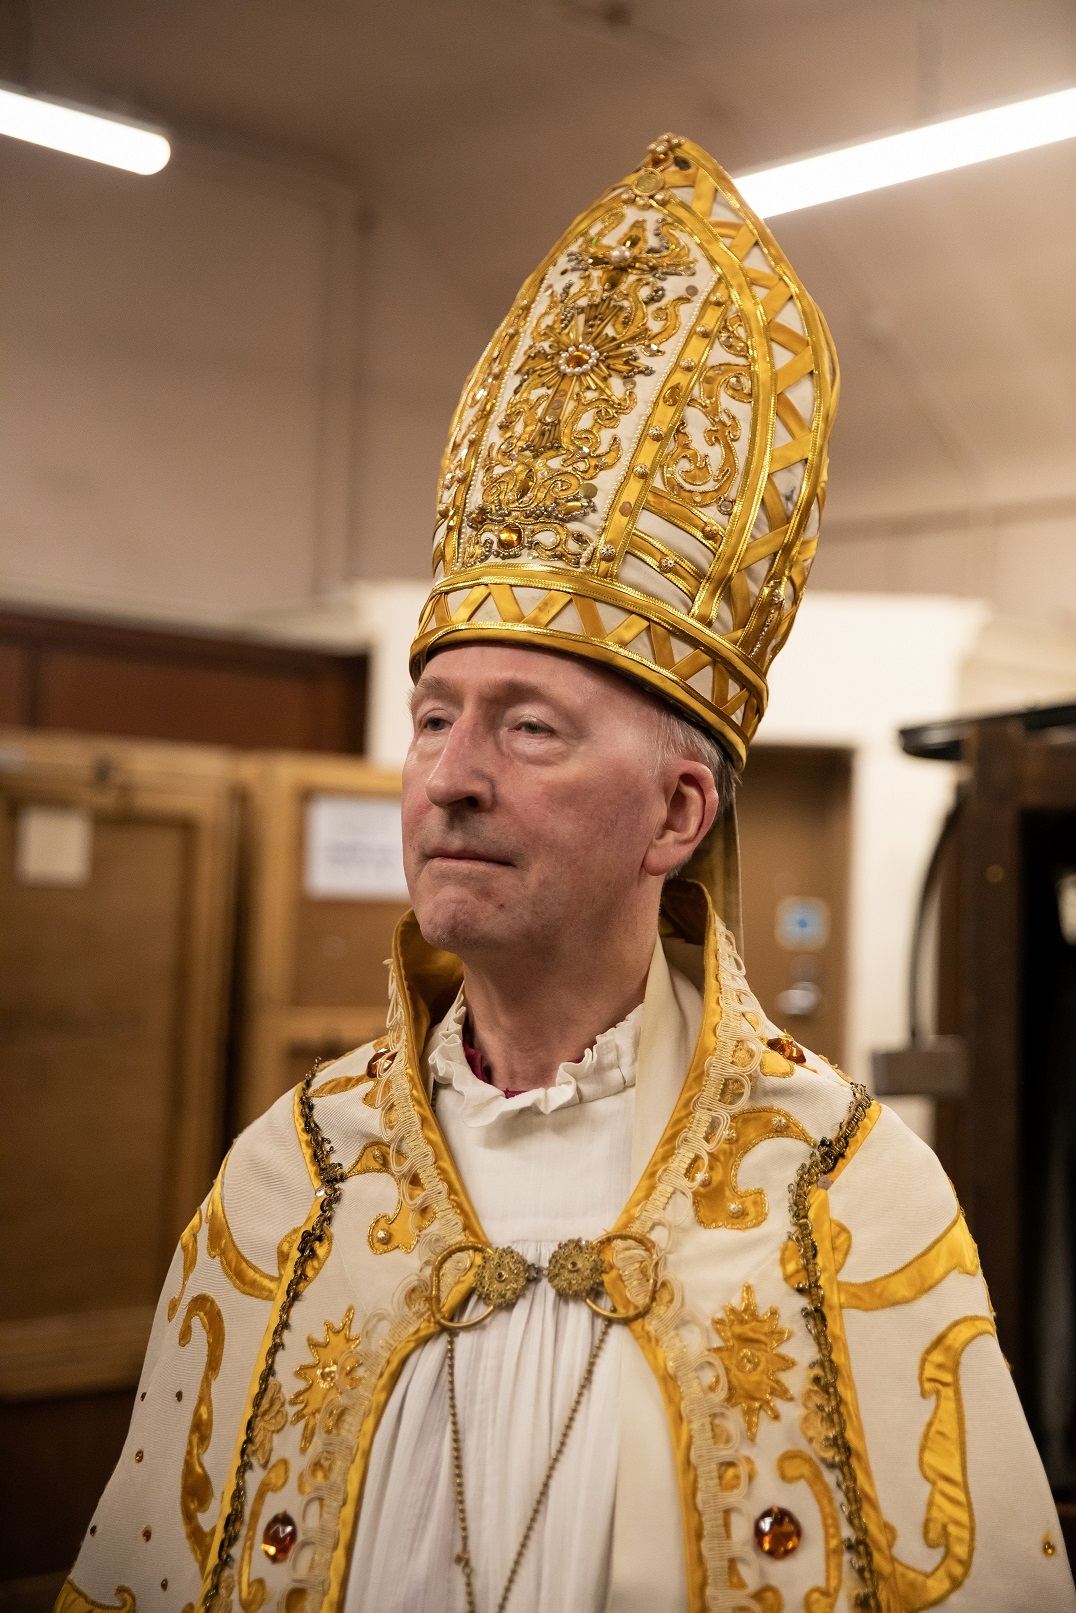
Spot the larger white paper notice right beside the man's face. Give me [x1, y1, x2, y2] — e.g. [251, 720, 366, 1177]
[303, 795, 407, 902]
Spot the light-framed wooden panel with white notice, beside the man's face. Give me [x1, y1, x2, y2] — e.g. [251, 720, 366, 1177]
[234, 753, 408, 1126]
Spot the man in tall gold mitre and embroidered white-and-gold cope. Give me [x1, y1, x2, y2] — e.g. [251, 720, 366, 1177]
[60, 137, 1076, 1613]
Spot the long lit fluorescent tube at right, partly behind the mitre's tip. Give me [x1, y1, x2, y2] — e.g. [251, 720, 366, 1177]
[736, 89, 1076, 218]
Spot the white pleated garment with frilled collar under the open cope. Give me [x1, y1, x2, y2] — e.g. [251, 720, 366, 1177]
[345, 997, 642, 1613]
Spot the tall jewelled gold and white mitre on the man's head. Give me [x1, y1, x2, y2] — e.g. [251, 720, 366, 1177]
[411, 134, 837, 765]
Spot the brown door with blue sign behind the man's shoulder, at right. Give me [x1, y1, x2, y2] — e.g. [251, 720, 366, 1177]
[737, 745, 852, 1063]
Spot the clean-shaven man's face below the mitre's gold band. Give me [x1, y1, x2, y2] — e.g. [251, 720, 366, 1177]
[403, 645, 666, 958]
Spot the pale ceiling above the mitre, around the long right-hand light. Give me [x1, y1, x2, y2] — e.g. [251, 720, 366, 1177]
[10, 0, 1076, 554]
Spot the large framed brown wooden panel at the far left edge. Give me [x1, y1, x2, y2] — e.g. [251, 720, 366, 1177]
[0, 729, 237, 1342]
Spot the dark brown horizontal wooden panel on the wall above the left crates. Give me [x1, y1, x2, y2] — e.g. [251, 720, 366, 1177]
[0, 613, 366, 752]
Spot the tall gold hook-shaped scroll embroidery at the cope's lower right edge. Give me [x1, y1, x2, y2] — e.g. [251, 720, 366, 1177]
[894, 1316, 994, 1613]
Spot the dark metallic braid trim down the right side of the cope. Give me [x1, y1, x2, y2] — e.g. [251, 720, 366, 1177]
[789, 1082, 882, 1613]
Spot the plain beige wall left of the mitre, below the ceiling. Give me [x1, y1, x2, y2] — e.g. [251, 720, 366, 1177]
[0, 140, 484, 623]
